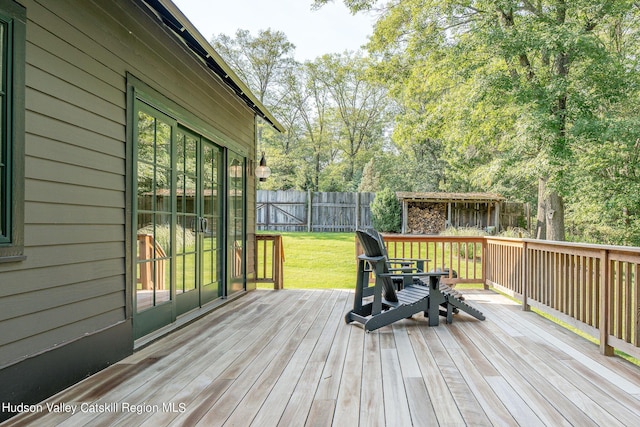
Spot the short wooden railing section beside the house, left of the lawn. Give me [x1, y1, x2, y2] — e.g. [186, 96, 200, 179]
[256, 234, 284, 289]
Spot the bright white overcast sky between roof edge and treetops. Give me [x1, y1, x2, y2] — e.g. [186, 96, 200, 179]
[173, 0, 374, 61]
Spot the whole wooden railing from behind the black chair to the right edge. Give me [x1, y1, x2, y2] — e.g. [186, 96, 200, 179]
[368, 234, 640, 358]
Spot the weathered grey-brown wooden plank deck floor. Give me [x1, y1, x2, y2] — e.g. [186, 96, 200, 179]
[6, 290, 640, 427]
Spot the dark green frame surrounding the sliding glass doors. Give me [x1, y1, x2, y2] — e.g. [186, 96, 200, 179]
[127, 82, 247, 339]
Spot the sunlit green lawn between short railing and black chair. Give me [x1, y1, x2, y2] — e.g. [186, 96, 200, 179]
[258, 232, 356, 289]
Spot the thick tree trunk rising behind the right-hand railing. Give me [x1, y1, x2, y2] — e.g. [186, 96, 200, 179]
[536, 178, 565, 241]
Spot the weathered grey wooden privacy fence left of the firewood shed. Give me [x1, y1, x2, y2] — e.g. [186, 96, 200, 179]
[256, 190, 375, 232]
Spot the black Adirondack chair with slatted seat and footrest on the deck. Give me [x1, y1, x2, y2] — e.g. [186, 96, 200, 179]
[345, 230, 484, 331]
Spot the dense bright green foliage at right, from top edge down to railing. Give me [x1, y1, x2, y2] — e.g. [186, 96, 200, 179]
[315, 0, 640, 244]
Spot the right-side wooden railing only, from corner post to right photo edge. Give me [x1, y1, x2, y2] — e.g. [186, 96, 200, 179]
[486, 238, 640, 357]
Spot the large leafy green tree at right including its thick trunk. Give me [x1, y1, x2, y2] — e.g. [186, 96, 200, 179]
[322, 0, 637, 240]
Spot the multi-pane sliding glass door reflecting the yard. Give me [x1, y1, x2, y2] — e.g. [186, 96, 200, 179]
[132, 98, 240, 338]
